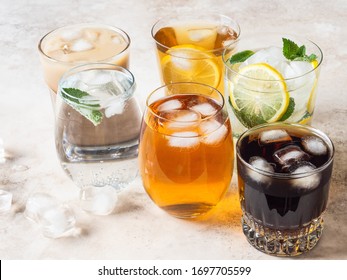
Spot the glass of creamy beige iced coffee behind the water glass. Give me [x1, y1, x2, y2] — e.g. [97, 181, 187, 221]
[38, 24, 130, 103]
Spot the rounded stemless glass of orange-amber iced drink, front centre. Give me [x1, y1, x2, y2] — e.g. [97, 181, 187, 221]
[139, 83, 234, 218]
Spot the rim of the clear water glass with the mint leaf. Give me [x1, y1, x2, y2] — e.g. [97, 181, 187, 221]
[58, 62, 136, 104]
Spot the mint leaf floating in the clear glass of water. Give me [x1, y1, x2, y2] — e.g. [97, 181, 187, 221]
[60, 88, 103, 126]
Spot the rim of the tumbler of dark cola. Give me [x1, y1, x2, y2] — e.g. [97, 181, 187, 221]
[235, 122, 335, 179]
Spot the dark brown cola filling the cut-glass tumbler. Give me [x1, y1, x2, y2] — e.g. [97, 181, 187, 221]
[237, 129, 332, 229]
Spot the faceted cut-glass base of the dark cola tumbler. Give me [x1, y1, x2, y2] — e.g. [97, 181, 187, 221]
[242, 213, 323, 257]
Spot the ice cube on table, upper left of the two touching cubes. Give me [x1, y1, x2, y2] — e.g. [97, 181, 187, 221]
[24, 193, 58, 223]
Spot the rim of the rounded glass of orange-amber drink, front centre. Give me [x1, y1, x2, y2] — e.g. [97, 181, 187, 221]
[146, 82, 225, 124]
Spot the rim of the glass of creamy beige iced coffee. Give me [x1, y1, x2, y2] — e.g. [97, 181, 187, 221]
[37, 23, 131, 65]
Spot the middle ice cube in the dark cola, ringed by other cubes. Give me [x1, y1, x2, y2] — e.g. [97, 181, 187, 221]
[273, 145, 310, 167]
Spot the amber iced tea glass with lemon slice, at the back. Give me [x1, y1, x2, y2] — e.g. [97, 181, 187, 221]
[152, 13, 240, 92]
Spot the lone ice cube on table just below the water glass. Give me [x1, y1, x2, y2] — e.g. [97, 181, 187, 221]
[80, 186, 118, 215]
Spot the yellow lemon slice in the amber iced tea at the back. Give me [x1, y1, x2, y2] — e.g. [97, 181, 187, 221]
[161, 44, 221, 87]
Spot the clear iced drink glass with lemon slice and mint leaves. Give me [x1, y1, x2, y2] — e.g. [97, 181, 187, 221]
[223, 33, 323, 138]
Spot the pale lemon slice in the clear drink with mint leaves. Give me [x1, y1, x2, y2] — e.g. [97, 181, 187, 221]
[229, 63, 290, 128]
